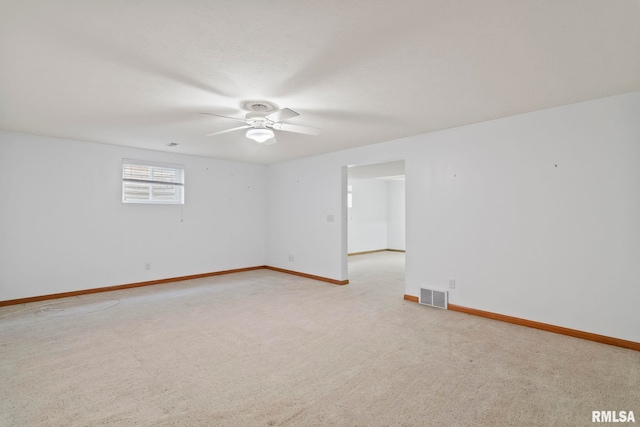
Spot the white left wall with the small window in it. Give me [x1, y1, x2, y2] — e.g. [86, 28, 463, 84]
[0, 132, 265, 300]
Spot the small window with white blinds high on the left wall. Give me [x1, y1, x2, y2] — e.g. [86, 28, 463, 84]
[122, 159, 184, 205]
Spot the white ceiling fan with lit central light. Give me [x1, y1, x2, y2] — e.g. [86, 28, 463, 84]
[200, 101, 320, 145]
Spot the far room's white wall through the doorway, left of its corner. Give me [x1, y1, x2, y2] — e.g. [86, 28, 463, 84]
[348, 179, 387, 253]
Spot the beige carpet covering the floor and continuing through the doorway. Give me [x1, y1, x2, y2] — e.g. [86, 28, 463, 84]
[0, 252, 640, 426]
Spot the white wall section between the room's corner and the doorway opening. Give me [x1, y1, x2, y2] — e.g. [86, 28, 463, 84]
[266, 157, 347, 280]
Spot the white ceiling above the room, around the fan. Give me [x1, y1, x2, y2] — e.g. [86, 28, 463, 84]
[0, 0, 640, 164]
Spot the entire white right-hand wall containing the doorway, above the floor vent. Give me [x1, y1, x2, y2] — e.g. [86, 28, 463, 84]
[267, 92, 640, 341]
